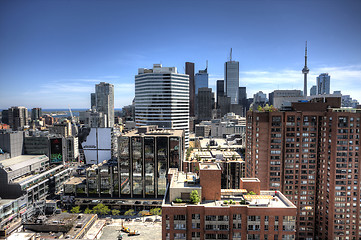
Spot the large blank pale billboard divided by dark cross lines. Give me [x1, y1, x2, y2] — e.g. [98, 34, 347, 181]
[81, 128, 112, 164]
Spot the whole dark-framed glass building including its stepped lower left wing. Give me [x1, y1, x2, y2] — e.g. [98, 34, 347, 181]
[64, 126, 184, 198]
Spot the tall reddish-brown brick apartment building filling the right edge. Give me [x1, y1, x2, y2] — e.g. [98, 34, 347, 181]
[245, 98, 361, 240]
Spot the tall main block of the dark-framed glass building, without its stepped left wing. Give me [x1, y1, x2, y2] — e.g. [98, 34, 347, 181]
[118, 126, 185, 197]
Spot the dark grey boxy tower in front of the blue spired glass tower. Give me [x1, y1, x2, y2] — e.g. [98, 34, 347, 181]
[197, 87, 215, 120]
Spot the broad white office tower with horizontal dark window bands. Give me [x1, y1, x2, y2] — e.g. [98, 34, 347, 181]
[135, 64, 189, 147]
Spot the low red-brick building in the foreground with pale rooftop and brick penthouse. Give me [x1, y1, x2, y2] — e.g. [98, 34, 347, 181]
[162, 163, 296, 240]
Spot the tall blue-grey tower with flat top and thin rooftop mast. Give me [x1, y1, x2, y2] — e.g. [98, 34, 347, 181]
[224, 48, 239, 104]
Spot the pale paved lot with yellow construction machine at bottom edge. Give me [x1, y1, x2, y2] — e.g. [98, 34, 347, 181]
[100, 216, 162, 240]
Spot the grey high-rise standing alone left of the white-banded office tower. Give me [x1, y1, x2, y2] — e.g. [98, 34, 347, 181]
[95, 82, 114, 127]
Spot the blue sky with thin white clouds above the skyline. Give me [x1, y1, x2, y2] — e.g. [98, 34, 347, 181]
[0, 0, 361, 109]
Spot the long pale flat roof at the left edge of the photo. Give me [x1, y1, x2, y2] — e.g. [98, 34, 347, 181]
[0, 155, 49, 171]
